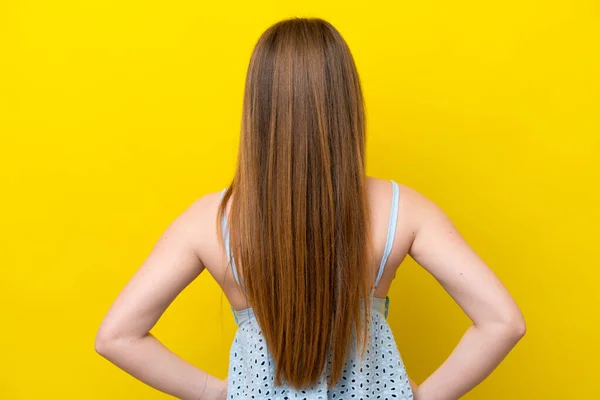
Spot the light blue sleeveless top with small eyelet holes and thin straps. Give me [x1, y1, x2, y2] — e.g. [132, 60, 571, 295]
[221, 180, 413, 400]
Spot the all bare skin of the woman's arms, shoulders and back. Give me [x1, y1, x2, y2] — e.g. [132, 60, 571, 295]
[96, 177, 525, 400]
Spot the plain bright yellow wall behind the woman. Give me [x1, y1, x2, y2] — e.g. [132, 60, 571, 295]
[0, 0, 600, 400]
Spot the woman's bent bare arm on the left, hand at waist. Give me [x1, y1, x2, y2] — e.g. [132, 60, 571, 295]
[96, 197, 227, 400]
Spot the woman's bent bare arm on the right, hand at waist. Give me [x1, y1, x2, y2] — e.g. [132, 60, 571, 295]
[404, 188, 525, 400]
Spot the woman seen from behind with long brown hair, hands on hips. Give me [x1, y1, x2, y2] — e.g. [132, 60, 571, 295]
[96, 19, 525, 400]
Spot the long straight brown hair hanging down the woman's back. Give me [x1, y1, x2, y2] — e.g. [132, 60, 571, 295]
[217, 18, 374, 388]
